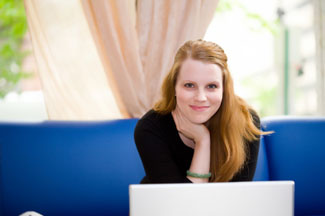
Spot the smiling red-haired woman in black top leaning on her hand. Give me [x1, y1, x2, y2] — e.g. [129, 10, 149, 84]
[134, 40, 264, 183]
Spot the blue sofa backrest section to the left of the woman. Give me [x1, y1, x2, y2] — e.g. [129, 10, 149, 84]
[0, 119, 144, 215]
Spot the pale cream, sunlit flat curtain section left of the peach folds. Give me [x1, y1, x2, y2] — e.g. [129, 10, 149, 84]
[25, 0, 122, 120]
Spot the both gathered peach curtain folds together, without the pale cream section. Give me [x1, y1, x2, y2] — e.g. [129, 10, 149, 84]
[83, 0, 218, 117]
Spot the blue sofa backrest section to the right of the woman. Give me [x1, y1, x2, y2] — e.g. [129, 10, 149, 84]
[258, 117, 325, 215]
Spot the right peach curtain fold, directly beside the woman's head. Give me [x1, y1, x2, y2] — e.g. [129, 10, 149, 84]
[137, 0, 218, 108]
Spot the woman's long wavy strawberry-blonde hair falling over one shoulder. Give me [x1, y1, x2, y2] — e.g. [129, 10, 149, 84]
[154, 39, 268, 182]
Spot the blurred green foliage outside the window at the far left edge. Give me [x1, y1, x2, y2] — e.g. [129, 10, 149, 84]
[0, 0, 29, 98]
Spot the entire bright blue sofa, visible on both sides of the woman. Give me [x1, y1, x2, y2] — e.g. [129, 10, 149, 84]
[0, 117, 325, 216]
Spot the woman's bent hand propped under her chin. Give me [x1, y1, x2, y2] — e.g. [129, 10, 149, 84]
[172, 107, 210, 144]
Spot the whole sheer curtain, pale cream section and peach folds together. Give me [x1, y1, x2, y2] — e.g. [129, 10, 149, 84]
[25, 0, 218, 119]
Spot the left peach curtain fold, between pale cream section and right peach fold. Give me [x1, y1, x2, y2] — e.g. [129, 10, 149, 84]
[82, 0, 148, 117]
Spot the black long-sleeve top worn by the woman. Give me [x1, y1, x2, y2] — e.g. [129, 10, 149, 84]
[134, 110, 260, 183]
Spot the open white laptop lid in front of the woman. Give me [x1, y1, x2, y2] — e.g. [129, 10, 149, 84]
[129, 181, 294, 216]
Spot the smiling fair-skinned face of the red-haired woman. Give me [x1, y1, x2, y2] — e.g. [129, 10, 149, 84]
[175, 58, 223, 124]
